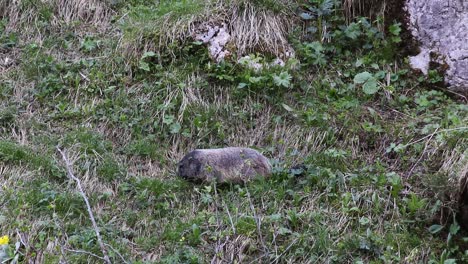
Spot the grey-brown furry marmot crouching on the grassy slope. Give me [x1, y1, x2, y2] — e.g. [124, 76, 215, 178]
[178, 147, 271, 183]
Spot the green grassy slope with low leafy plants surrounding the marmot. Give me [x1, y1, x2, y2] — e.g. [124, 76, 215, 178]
[0, 1, 467, 263]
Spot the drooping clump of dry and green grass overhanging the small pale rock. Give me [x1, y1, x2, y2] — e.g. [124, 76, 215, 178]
[119, 0, 296, 62]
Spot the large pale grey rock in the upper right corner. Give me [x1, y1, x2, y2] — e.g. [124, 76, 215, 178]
[407, 0, 468, 92]
